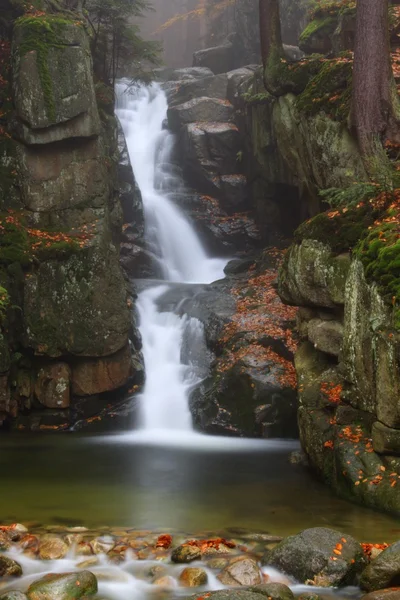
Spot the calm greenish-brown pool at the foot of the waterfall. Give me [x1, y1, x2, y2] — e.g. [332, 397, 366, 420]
[0, 434, 400, 542]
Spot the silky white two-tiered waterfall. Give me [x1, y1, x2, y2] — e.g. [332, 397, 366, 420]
[117, 82, 226, 432]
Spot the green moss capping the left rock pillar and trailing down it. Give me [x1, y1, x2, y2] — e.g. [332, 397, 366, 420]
[15, 15, 81, 122]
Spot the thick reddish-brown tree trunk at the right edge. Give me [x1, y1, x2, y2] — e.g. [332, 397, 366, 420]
[352, 0, 400, 157]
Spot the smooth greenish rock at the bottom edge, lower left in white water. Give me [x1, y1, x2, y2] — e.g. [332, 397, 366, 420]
[27, 571, 97, 600]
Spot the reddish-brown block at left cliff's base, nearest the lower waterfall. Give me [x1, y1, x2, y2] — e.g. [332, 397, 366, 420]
[72, 345, 133, 396]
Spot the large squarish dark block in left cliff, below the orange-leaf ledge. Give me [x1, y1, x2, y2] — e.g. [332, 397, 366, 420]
[23, 235, 131, 357]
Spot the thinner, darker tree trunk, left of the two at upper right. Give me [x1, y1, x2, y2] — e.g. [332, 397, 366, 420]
[259, 0, 285, 96]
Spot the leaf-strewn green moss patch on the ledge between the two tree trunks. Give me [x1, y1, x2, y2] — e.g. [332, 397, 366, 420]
[297, 54, 353, 121]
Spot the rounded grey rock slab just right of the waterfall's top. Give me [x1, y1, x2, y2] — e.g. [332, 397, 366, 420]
[168, 97, 234, 133]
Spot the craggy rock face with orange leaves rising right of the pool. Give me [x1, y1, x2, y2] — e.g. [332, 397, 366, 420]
[279, 232, 400, 512]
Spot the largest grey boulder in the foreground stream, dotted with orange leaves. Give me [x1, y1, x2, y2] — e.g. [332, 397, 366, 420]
[264, 527, 366, 587]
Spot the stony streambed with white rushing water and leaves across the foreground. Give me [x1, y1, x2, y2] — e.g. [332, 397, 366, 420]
[0, 524, 400, 600]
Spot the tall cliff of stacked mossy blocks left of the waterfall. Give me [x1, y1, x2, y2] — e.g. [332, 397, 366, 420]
[0, 13, 143, 429]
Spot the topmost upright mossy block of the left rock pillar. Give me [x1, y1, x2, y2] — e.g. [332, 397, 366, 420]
[13, 15, 100, 144]
